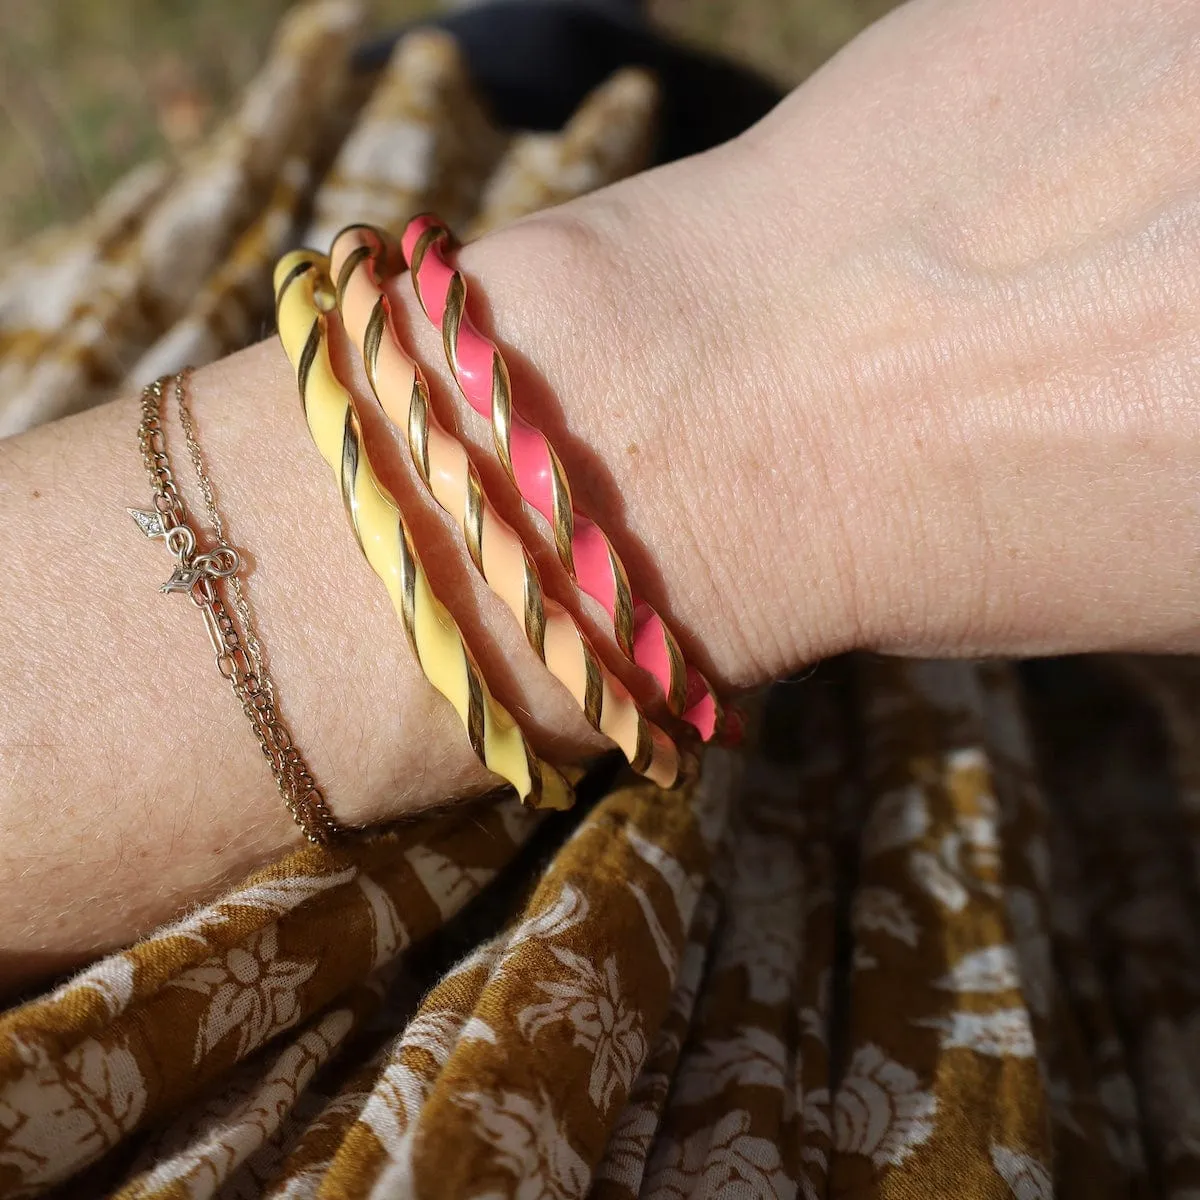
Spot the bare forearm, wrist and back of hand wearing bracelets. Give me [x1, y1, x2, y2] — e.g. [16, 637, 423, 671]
[0, 2, 1200, 979]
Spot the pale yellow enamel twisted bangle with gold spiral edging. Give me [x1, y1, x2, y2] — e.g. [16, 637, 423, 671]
[275, 250, 574, 809]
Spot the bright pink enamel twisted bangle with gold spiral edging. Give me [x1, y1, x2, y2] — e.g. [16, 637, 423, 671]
[402, 214, 722, 742]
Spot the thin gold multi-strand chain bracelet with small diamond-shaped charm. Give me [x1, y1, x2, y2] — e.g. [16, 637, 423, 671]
[128, 371, 341, 845]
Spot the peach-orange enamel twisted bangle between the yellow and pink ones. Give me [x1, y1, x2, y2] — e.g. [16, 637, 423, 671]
[330, 224, 679, 787]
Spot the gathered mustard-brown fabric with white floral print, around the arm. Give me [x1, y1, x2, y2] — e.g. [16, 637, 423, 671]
[0, 0, 1200, 1200]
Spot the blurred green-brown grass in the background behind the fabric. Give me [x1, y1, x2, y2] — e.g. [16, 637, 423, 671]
[0, 0, 894, 247]
